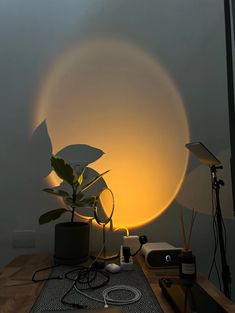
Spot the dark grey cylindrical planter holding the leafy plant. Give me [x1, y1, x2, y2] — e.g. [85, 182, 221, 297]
[54, 222, 90, 265]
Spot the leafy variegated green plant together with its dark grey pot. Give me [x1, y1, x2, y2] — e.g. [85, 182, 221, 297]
[39, 155, 108, 264]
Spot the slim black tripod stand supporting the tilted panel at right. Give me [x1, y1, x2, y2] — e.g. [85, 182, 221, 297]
[210, 165, 231, 299]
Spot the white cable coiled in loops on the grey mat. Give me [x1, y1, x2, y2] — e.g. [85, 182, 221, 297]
[74, 285, 142, 307]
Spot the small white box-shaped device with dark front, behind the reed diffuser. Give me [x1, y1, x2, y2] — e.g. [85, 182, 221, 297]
[141, 242, 182, 268]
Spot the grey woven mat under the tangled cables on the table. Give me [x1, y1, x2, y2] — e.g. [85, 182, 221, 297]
[30, 265, 163, 313]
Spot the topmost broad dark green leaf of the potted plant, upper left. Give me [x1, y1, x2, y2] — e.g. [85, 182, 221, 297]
[51, 155, 76, 185]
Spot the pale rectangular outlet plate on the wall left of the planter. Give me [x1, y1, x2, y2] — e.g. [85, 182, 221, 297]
[12, 229, 36, 249]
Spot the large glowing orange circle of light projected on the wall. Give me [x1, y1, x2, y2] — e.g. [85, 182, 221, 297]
[33, 38, 189, 228]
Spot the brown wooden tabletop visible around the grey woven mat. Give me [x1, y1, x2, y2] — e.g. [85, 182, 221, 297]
[0, 254, 235, 313]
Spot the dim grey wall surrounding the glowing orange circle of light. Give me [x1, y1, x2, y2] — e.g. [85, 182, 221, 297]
[0, 0, 235, 298]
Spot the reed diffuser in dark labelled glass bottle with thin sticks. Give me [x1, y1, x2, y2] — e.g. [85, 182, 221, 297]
[179, 209, 197, 280]
